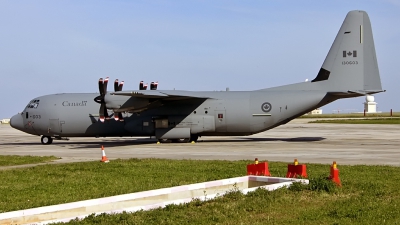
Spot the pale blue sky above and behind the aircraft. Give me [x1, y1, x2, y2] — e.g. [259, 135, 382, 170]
[0, 0, 400, 119]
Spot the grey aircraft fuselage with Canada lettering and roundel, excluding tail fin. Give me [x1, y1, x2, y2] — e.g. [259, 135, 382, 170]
[12, 91, 326, 141]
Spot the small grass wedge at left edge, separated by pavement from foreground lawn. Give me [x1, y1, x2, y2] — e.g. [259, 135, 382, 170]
[0, 155, 59, 166]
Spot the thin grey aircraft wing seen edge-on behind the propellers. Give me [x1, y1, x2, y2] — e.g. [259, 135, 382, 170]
[111, 90, 210, 100]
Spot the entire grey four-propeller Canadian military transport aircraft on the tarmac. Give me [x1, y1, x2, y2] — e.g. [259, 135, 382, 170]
[11, 11, 383, 144]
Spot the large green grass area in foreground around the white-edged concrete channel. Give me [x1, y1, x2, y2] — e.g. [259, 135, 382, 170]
[0, 159, 400, 224]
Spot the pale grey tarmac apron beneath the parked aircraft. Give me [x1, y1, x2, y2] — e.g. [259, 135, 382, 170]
[0, 119, 400, 166]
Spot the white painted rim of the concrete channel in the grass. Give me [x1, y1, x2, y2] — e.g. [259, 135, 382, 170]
[0, 176, 308, 224]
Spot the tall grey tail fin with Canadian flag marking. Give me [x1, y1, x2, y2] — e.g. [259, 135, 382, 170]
[311, 11, 382, 94]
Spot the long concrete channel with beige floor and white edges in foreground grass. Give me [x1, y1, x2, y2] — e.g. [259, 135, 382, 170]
[0, 176, 308, 224]
